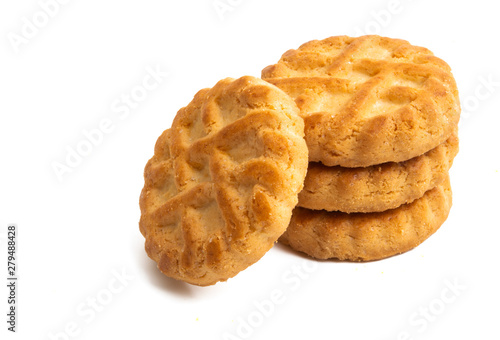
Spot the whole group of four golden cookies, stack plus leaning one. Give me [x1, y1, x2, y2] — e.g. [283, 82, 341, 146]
[139, 36, 460, 286]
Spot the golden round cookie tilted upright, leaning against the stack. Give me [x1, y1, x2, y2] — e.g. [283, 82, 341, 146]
[139, 77, 308, 286]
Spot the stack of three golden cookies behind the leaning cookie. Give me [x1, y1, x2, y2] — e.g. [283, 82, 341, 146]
[262, 36, 460, 261]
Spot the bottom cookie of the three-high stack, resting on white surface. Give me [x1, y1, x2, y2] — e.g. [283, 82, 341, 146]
[279, 178, 451, 261]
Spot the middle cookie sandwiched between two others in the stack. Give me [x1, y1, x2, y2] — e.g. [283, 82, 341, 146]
[298, 133, 458, 213]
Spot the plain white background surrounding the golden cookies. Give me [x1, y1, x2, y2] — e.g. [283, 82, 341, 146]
[0, 0, 500, 340]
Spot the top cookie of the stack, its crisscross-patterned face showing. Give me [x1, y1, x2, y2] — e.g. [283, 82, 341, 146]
[262, 35, 460, 167]
